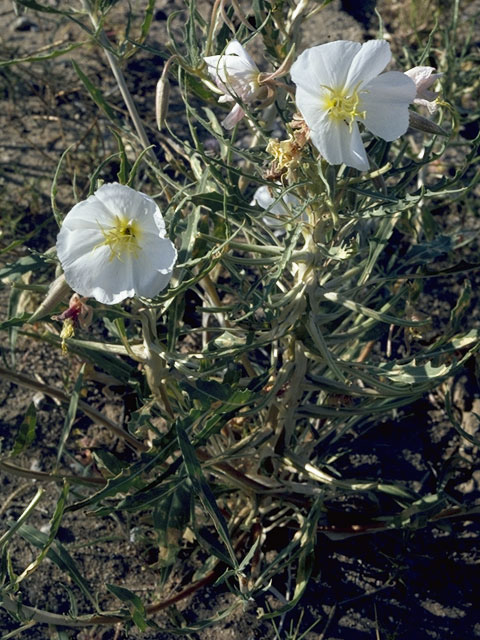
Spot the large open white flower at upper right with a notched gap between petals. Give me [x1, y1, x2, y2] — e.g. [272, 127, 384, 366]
[290, 40, 416, 171]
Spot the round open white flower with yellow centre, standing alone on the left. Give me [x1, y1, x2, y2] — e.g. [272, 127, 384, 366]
[57, 182, 177, 304]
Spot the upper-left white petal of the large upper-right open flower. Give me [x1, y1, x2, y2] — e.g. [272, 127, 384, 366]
[290, 40, 361, 93]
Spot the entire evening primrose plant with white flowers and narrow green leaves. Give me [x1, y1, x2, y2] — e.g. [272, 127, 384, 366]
[0, 0, 480, 634]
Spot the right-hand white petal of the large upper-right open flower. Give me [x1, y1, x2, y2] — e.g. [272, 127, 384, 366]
[361, 71, 416, 141]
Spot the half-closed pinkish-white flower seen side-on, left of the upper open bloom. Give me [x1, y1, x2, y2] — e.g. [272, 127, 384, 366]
[204, 40, 263, 129]
